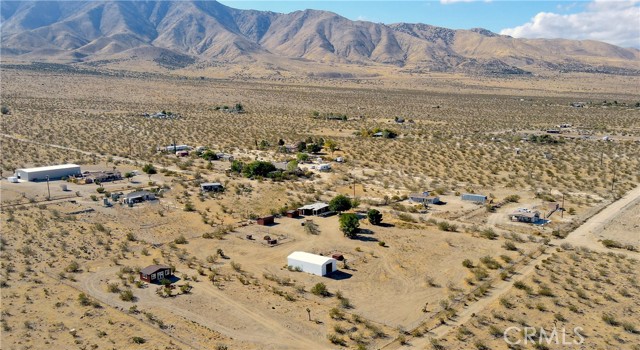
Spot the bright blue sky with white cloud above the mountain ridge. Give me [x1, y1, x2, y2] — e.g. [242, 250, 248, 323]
[219, 0, 640, 48]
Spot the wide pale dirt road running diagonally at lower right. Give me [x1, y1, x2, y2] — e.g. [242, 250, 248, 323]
[385, 186, 640, 349]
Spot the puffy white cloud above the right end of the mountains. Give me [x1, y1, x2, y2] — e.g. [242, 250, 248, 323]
[500, 0, 640, 48]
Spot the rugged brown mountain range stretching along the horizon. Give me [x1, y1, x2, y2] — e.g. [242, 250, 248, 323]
[0, 1, 640, 75]
